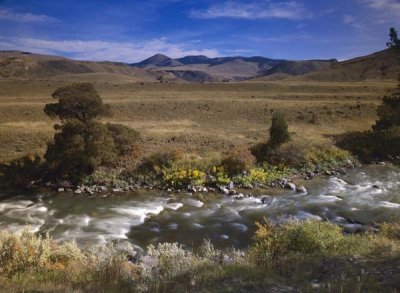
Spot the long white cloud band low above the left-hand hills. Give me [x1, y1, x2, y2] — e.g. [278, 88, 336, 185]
[0, 38, 219, 62]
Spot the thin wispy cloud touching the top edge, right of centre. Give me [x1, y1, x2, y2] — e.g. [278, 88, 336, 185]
[191, 0, 311, 20]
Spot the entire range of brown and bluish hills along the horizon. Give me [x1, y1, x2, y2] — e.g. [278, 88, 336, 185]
[0, 48, 400, 82]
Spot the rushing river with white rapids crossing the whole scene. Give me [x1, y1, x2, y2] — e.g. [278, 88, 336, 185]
[0, 165, 400, 248]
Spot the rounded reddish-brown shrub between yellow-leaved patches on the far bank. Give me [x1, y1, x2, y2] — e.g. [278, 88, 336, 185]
[222, 147, 256, 174]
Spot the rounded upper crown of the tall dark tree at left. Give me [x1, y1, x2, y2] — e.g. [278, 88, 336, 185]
[44, 83, 110, 123]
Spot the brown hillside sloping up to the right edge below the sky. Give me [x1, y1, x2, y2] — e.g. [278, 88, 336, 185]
[299, 49, 400, 81]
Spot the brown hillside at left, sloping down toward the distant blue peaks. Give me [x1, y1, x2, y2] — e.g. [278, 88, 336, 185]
[0, 51, 154, 81]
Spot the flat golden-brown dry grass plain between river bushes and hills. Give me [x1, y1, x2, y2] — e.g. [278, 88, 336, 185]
[0, 75, 395, 160]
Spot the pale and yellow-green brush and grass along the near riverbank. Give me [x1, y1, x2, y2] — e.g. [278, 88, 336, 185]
[0, 221, 400, 292]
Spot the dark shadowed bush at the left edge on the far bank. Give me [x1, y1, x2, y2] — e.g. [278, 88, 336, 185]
[0, 155, 43, 188]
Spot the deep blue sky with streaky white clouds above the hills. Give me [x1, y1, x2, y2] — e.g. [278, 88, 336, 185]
[0, 0, 400, 63]
